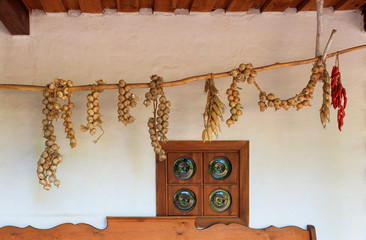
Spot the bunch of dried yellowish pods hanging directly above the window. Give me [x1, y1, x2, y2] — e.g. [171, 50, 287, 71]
[202, 76, 225, 142]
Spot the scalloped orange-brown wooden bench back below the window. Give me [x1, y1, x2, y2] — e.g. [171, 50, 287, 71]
[0, 217, 316, 240]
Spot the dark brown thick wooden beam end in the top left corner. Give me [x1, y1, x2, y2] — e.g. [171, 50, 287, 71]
[0, 0, 29, 35]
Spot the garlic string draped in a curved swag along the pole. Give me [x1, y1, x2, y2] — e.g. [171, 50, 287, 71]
[258, 65, 325, 112]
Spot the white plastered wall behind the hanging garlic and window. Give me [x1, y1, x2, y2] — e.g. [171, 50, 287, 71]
[0, 10, 366, 240]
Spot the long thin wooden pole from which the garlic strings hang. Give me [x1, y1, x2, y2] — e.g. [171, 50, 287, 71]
[0, 44, 366, 92]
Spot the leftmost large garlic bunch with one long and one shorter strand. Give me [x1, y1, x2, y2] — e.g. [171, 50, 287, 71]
[37, 79, 76, 190]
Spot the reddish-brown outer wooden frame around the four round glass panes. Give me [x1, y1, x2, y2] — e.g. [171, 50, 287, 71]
[156, 141, 249, 228]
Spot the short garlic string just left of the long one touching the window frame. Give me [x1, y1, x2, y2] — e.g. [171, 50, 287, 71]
[118, 80, 137, 126]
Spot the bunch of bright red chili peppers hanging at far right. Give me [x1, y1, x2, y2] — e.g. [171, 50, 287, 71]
[331, 61, 347, 131]
